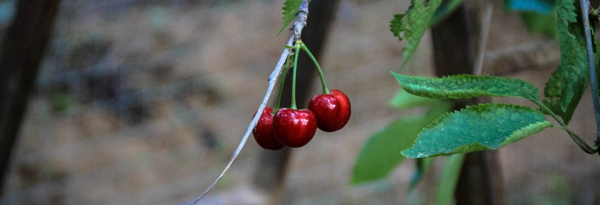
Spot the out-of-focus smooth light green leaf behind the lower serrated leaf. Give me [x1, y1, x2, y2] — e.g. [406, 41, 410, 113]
[351, 101, 452, 184]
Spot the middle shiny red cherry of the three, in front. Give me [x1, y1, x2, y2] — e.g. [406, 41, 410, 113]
[273, 108, 317, 147]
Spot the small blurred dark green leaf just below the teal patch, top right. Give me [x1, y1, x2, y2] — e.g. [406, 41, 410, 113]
[521, 9, 558, 38]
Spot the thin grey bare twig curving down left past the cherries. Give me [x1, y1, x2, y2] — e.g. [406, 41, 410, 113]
[192, 0, 308, 205]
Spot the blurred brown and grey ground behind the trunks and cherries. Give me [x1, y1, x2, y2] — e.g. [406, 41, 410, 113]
[0, 0, 600, 205]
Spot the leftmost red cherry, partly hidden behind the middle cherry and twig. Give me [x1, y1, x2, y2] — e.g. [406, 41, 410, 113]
[252, 107, 285, 150]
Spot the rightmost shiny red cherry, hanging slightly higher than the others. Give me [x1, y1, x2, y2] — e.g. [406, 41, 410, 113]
[308, 90, 351, 132]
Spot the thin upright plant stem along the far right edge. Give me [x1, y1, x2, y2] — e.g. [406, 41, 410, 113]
[579, 0, 600, 152]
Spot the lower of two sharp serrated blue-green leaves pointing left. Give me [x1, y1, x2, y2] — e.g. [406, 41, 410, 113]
[402, 103, 552, 158]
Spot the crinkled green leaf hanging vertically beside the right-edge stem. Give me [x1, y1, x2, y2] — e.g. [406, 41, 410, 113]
[544, 0, 589, 124]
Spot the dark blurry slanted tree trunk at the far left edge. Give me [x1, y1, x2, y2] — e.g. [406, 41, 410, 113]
[0, 0, 60, 193]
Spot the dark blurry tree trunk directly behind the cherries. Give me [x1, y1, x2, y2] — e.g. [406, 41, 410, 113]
[254, 0, 338, 204]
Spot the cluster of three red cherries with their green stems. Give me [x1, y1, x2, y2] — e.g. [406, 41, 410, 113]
[252, 41, 351, 150]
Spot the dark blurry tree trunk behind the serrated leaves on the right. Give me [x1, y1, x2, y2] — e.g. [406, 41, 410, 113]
[431, 3, 504, 205]
